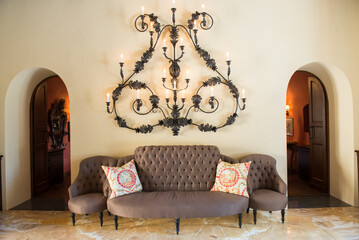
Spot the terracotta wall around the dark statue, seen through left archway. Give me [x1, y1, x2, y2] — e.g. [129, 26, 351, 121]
[46, 76, 71, 173]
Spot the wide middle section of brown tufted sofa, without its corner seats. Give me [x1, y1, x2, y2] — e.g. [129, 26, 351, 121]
[105, 146, 249, 234]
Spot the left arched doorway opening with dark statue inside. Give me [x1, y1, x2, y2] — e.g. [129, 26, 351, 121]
[30, 75, 71, 210]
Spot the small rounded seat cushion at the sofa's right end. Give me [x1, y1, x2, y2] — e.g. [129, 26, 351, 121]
[249, 189, 288, 211]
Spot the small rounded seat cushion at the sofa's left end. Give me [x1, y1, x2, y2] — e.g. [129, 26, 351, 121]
[68, 193, 107, 214]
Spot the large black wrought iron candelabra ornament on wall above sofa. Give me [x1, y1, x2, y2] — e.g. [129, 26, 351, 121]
[106, 3, 246, 136]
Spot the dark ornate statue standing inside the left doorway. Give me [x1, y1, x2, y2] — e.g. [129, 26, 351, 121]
[47, 99, 68, 149]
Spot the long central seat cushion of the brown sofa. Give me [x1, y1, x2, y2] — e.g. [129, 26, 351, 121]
[107, 191, 248, 218]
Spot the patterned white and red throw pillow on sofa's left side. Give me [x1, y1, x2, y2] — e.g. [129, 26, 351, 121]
[102, 160, 142, 199]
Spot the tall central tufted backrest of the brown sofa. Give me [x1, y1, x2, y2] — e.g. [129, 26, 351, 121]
[134, 145, 221, 191]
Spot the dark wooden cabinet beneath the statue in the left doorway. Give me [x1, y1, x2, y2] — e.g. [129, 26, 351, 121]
[48, 148, 64, 185]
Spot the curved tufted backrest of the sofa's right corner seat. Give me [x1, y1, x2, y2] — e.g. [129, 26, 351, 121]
[240, 154, 286, 195]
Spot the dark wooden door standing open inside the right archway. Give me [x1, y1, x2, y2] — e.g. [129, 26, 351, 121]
[308, 77, 329, 192]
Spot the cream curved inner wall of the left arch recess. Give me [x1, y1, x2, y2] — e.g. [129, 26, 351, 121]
[2, 68, 64, 209]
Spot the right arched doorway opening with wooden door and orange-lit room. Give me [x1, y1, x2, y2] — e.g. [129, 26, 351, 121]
[286, 71, 329, 196]
